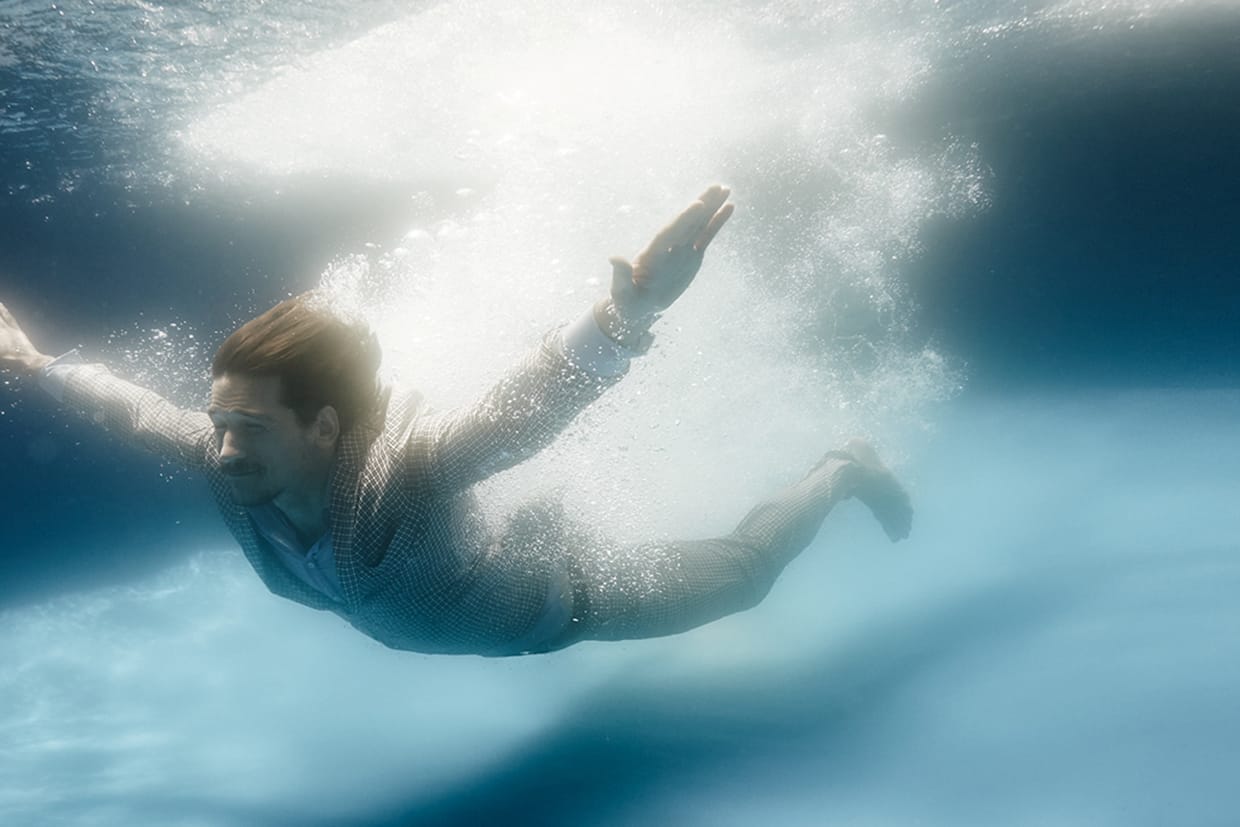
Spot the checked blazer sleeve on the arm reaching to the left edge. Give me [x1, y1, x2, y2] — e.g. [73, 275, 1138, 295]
[53, 365, 215, 470]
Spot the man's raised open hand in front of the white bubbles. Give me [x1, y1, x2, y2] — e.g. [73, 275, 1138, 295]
[611, 184, 734, 330]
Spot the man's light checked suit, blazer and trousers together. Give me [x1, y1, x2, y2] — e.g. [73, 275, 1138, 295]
[55, 332, 849, 655]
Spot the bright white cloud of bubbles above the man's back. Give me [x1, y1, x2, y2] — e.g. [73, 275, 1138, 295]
[172, 0, 1210, 536]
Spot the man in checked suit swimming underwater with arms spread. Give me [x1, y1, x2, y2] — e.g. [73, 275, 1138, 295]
[0, 186, 913, 655]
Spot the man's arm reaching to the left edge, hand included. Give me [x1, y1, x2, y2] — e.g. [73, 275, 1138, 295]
[0, 305, 212, 467]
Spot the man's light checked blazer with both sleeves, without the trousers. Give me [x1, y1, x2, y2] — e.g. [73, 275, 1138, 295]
[55, 332, 624, 655]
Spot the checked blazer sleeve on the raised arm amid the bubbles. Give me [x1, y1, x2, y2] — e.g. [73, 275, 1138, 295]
[405, 331, 627, 492]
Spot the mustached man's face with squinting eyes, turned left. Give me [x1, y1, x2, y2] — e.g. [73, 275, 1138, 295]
[207, 373, 331, 506]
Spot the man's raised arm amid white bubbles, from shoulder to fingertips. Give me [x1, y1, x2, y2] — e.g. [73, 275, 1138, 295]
[408, 186, 733, 490]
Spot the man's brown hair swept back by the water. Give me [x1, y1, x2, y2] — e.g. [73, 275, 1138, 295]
[211, 293, 382, 431]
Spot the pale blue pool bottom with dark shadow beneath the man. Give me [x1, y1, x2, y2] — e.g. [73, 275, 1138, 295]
[0, 393, 1240, 825]
